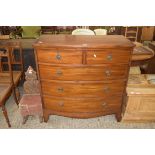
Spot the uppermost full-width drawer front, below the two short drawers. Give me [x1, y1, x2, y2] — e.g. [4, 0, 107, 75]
[39, 65, 128, 81]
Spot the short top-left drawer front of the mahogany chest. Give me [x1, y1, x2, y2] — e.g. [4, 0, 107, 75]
[37, 49, 82, 64]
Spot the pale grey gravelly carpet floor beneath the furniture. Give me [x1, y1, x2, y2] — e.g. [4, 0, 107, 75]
[0, 93, 155, 129]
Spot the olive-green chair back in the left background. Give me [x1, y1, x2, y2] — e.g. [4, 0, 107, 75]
[21, 26, 41, 38]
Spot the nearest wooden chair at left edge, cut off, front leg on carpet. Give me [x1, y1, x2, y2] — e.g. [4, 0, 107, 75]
[0, 48, 18, 127]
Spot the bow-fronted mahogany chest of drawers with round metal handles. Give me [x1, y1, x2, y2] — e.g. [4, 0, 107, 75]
[34, 35, 134, 122]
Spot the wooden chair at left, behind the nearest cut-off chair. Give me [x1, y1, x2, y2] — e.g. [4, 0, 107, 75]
[0, 42, 23, 102]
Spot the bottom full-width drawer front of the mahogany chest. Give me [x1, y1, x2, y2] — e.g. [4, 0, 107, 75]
[43, 96, 122, 113]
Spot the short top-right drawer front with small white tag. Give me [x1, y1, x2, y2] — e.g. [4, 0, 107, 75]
[87, 49, 131, 64]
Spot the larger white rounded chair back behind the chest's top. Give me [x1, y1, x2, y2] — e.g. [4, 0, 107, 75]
[72, 29, 95, 35]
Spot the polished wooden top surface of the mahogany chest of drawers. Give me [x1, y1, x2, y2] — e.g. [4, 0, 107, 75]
[34, 35, 134, 48]
